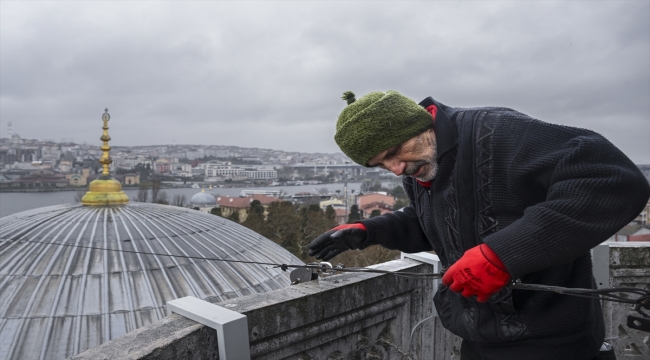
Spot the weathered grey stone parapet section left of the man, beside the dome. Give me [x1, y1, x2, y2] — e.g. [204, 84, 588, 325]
[73, 259, 434, 360]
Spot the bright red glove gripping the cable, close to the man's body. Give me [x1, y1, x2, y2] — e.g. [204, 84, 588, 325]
[442, 244, 510, 302]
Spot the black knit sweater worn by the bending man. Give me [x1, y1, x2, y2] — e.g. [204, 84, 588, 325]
[362, 98, 650, 360]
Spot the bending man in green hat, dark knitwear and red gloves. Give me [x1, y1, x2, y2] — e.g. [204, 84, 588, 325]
[309, 91, 650, 360]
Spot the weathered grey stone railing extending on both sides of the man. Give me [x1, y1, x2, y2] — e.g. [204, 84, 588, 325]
[74, 243, 650, 360]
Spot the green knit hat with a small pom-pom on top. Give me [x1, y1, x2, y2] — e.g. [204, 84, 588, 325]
[334, 90, 433, 166]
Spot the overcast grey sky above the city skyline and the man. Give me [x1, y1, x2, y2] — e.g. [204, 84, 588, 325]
[0, 0, 650, 164]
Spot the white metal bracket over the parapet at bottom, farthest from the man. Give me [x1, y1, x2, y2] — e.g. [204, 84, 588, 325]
[167, 296, 251, 360]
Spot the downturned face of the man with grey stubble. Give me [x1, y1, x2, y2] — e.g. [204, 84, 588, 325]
[368, 129, 438, 182]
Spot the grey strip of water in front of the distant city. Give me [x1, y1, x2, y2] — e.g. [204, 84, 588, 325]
[0, 183, 380, 217]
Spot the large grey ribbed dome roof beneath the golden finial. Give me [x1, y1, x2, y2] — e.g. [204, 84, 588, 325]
[0, 203, 302, 359]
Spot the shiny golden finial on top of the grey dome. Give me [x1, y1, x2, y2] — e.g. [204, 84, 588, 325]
[81, 108, 129, 205]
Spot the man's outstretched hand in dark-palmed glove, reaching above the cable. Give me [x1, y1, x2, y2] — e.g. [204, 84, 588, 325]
[309, 223, 367, 261]
